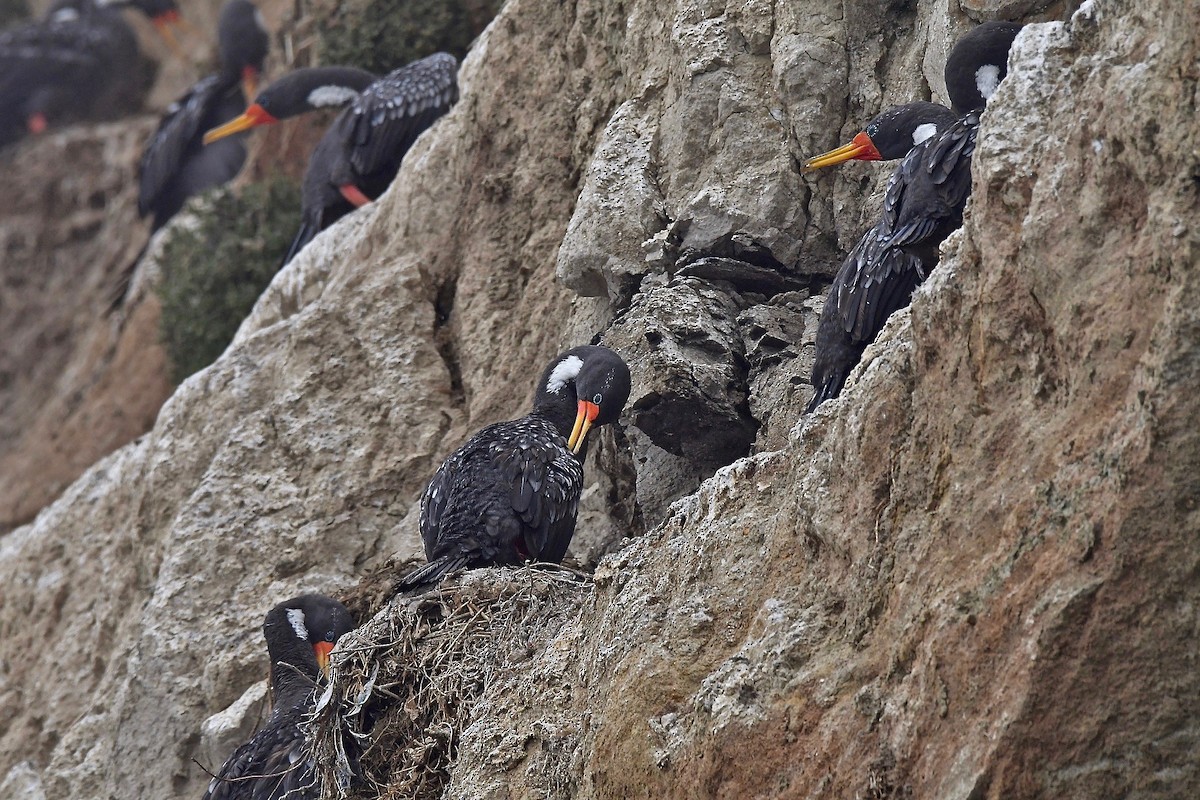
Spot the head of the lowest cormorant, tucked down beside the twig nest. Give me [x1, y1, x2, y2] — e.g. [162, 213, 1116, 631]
[263, 595, 354, 685]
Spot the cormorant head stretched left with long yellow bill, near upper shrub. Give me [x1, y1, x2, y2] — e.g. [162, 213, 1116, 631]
[204, 67, 377, 144]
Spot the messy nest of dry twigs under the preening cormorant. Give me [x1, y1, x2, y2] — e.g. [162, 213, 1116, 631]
[310, 565, 590, 800]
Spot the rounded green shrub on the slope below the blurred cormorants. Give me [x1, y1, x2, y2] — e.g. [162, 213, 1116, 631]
[158, 178, 300, 384]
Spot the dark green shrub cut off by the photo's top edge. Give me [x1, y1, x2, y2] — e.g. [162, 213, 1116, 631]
[318, 0, 504, 74]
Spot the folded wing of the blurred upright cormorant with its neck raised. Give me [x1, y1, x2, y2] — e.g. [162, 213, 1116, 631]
[138, 76, 231, 216]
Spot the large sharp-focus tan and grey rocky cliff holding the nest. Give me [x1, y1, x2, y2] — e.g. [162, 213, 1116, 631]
[0, 0, 1200, 799]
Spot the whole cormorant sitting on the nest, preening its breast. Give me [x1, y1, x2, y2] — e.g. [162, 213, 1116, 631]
[400, 345, 630, 589]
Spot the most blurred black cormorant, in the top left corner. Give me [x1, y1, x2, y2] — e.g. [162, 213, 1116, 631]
[0, 0, 179, 146]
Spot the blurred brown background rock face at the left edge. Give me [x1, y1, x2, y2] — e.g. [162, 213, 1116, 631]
[0, 118, 170, 534]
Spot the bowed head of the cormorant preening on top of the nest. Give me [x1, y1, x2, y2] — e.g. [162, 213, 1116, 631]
[534, 345, 631, 455]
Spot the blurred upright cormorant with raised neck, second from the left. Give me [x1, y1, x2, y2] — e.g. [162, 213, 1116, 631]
[138, 0, 269, 230]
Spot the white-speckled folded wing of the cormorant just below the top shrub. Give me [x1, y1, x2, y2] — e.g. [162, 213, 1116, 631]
[348, 53, 458, 175]
